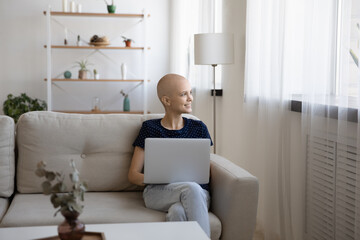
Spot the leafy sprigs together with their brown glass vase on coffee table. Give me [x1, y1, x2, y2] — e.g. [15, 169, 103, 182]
[35, 160, 88, 240]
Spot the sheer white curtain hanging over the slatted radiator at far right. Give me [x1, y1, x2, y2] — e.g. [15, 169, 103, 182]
[301, 0, 360, 239]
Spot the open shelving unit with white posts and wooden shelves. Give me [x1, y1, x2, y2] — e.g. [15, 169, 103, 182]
[43, 6, 150, 114]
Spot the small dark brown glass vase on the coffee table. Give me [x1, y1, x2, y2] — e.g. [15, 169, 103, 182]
[58, 211, 85, 240]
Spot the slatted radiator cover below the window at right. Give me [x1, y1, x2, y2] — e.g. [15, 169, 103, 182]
[305, 136, 360, 240]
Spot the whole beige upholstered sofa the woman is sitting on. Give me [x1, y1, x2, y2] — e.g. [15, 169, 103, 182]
[0, 112, 258, 240]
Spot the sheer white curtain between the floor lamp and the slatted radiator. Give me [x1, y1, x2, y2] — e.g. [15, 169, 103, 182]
[244, 0, 293, 239]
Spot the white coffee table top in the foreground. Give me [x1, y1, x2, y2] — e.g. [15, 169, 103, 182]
[0, 222, 209, 240]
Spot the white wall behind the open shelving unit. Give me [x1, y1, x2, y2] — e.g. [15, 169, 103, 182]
[0, 0, 169, 113]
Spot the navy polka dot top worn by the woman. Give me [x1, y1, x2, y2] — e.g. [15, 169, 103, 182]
[133, 117, 213, 191]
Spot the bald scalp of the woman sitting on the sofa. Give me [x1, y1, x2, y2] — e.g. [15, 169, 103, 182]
[157, 74, 187, 101]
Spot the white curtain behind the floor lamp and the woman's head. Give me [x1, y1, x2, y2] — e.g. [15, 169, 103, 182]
[170, 0, 214, 124]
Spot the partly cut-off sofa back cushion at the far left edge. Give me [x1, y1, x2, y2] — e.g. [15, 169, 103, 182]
[0, 115, 15, 197]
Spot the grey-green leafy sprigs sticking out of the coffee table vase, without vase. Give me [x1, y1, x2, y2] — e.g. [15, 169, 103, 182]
[35, 160, 88, 216]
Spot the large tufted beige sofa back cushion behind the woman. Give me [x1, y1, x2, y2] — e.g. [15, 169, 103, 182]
[16, 112, 196, 193]
